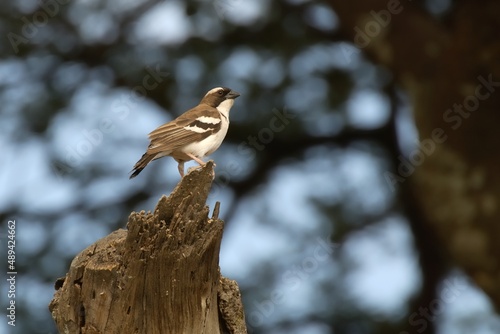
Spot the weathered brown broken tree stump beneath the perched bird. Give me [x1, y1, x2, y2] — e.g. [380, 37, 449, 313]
[49, 161, 246, 334]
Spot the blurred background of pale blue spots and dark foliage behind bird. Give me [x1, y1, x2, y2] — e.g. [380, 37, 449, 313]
[0, 0, 500, 334]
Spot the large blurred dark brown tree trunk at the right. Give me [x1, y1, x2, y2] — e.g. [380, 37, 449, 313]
[332, 0, 500, 310]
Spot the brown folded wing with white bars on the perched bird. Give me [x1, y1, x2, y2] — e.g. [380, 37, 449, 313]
[148, 105, 221, 154]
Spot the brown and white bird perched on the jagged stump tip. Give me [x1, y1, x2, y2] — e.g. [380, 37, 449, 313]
[130, 87, 240, 179]
